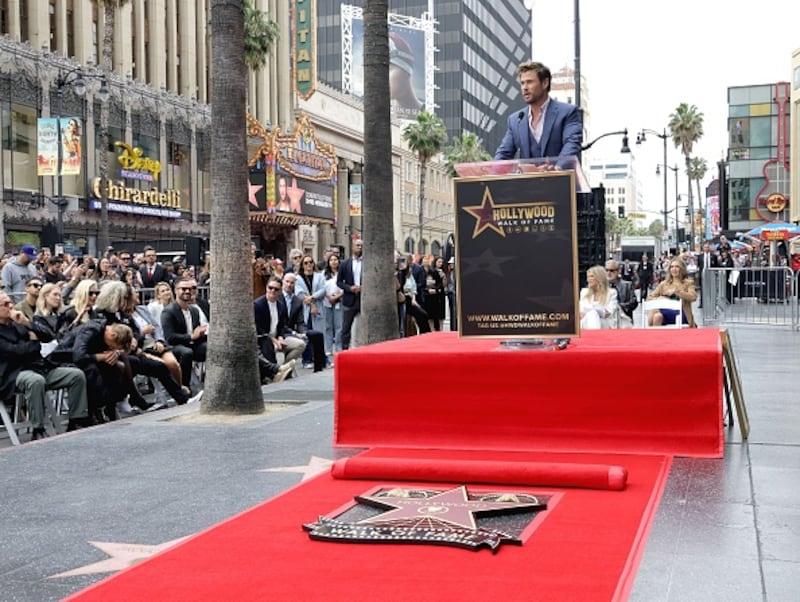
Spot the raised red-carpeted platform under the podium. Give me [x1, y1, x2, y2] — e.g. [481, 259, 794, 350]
[334, 328, 723, 457]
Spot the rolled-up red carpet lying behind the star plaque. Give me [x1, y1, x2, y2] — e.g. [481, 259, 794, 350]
[331, 456, 628, 491]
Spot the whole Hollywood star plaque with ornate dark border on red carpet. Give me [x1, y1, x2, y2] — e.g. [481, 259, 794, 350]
[303, 485, 549, 552]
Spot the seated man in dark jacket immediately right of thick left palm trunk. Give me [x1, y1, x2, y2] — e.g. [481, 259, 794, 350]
[253, 274, 306, 366]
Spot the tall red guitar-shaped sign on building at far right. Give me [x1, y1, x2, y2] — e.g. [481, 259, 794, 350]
[756, 82, 791, 222]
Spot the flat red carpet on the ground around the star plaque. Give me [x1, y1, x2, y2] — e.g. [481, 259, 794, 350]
[70, 449, 671, 602]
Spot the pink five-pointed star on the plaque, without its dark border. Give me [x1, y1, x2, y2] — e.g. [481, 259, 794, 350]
[356, 485, 542, 531]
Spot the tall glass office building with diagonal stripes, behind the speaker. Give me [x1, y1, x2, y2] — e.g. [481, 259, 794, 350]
[317, 0, 531, 154]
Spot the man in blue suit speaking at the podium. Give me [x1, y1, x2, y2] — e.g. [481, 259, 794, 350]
[494, 61, 583, 160]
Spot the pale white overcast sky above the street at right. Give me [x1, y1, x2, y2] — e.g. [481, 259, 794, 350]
[526, 0, 800, 211]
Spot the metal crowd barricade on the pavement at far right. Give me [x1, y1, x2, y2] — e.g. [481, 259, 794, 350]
[702, 266, 799, 327]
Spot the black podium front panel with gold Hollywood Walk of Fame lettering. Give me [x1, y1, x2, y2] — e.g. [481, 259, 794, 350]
[455, 171, 580, 338]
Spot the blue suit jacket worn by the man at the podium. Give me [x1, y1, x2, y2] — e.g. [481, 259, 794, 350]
[494, 98, 583, 161]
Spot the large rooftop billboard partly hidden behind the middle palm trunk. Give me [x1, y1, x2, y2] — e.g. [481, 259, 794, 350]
[342, 5, 435, 120]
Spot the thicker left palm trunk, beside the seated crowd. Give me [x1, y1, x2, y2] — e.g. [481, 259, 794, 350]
[201, 0, 264, 414]
